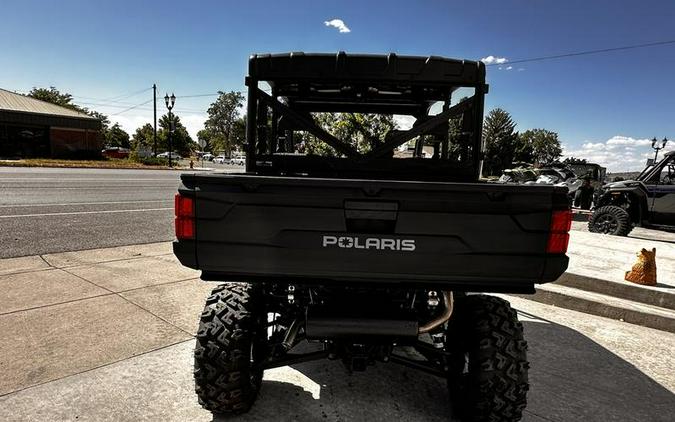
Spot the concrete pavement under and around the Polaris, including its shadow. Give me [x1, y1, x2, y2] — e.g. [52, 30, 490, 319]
[0, 243, 675, 421]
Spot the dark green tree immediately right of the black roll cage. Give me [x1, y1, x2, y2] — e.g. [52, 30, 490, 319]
[483, 108, 518, 175]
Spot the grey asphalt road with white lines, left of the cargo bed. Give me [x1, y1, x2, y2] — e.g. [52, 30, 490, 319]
[0, 167, 240, 258]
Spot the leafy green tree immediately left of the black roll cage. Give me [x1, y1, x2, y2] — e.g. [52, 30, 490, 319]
[204, 91, 244, 153]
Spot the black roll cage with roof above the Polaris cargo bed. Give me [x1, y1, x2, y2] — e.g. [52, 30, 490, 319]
[246, 52, 488, 181]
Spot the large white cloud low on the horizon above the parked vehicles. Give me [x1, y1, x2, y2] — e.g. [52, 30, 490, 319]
[563, 135, 675, 172]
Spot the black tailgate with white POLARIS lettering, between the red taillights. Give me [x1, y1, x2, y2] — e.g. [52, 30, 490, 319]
[175, 174, 567, 291]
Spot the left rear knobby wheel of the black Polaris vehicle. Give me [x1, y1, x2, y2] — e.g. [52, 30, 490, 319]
[194, 283, 265, 414]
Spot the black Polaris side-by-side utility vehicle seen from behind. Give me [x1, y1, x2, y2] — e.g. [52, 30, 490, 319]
[174, 52, 571, 421]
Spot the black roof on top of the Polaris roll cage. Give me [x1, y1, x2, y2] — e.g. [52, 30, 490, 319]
[248, 52, 486, 114]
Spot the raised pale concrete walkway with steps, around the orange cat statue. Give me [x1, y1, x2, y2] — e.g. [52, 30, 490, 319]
[521, 231, 675, 333]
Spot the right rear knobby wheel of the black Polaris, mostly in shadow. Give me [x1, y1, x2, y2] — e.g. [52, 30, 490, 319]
[446, 295, 529, 422]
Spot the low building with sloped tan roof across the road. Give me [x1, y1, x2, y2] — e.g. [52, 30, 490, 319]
[0, 89, 103, 158]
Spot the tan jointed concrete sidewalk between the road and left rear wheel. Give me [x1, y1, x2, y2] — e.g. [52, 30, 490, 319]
[0, 243, 206, 395]
